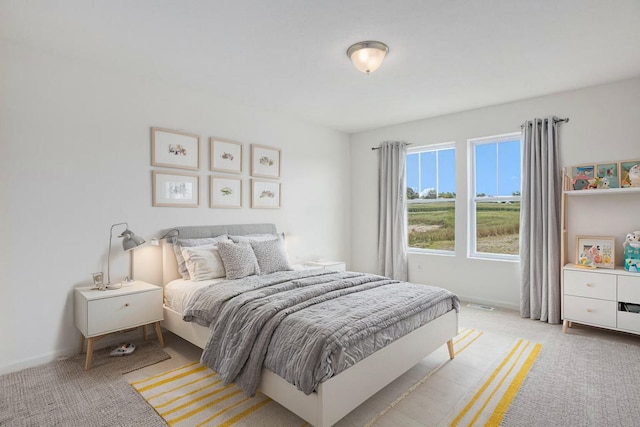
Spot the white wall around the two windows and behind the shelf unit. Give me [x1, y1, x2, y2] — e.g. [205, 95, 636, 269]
[351, 78, 640, 308]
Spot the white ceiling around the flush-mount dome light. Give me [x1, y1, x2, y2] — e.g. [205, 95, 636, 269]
[0, 0, 640, 133]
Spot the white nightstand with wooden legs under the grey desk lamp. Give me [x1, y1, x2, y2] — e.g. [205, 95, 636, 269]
[74, 281, 164, 370]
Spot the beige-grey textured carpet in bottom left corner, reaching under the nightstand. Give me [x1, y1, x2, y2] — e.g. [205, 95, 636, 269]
[0, 341, 170, 427]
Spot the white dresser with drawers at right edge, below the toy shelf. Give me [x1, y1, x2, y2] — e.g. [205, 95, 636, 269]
[562, 264, 640, 334]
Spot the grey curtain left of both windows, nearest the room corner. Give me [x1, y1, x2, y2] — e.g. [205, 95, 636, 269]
[378, 141, 408, 281]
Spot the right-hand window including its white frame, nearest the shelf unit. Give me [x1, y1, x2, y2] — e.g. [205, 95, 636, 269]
[469, 133, 522, 259]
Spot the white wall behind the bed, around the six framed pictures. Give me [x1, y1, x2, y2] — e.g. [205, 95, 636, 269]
[0, 42, 350, 372]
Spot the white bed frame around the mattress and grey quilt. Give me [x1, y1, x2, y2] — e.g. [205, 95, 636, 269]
[162, 224, 458, 427]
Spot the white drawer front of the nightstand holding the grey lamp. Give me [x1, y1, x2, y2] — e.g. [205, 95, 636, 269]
[87, 288, 163, 337]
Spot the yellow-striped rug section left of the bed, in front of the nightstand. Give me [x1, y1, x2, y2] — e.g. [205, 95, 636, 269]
[131, 362, 305, 427]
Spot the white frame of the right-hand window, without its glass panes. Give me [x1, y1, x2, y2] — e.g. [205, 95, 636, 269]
[467, 132, 522, 261]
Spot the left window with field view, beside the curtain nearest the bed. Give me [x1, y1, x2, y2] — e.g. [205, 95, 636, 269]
[407, 143, 456, 251]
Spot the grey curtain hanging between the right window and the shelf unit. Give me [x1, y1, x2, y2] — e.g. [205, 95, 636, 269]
[520, 117, 562, 323]
